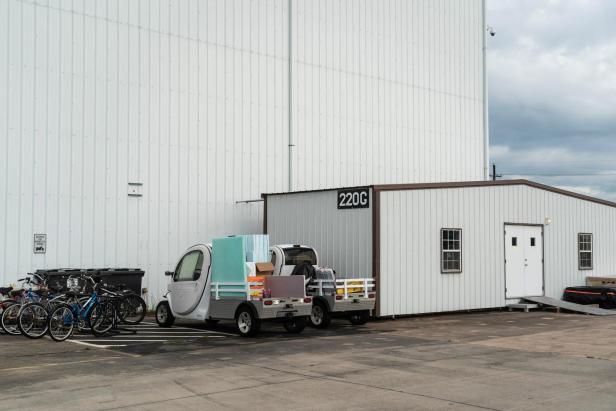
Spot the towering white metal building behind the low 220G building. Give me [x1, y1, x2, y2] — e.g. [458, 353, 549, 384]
[0, 0, 488, 303]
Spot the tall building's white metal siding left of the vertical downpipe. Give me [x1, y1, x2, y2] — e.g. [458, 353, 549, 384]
[0, 0, 287, 303]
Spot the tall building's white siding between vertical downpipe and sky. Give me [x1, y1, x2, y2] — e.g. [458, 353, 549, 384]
[293, 0, 485, 190]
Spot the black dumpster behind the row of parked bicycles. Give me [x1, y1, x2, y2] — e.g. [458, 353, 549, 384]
[36, 268, 145, 295]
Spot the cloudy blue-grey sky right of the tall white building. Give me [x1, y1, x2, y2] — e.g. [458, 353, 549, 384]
[488, 0, 616, 200]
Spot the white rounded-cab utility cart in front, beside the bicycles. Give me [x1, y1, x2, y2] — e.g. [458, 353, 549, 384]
[156, 244, 312, 336]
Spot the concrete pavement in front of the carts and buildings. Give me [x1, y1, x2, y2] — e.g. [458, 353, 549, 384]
[0, 312, 616, 410]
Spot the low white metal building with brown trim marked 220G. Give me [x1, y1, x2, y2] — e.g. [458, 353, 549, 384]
[264, 180, 616, 316]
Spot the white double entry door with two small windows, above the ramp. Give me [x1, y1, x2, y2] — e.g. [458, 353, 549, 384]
[505, 225, 543, 298]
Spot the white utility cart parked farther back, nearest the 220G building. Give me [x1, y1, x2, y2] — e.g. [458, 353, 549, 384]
[270, 244, 376, 328]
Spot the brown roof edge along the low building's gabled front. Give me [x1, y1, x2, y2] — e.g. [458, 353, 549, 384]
[373, 179, 616, 208]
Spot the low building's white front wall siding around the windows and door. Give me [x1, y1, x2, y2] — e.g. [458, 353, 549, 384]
[379, 186, 616, 316]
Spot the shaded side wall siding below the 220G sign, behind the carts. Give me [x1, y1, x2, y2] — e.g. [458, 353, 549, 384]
[267, 190, 372, 278]
